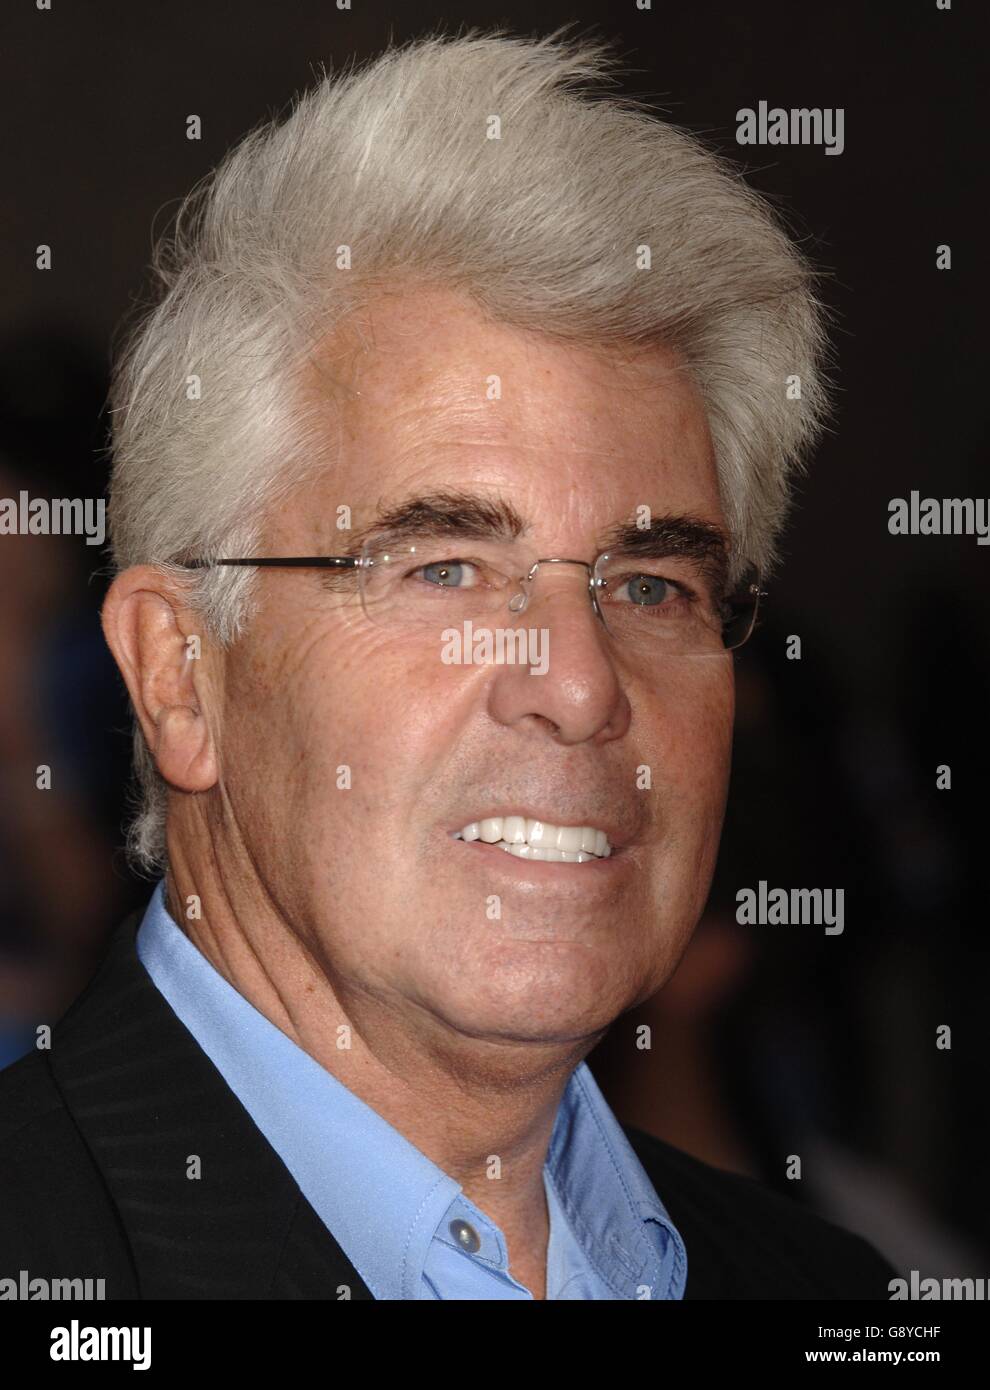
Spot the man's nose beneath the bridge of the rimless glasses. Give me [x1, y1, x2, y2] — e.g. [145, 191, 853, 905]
[488, 560, 631, 744]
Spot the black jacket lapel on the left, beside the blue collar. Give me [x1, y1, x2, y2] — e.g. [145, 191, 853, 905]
[50, 913, 373, 1301]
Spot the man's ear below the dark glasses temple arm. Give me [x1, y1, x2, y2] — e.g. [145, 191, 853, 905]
[102, 564, 220, 791]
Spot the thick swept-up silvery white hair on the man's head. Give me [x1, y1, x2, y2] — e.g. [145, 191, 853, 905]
[110, 31, 829, 873]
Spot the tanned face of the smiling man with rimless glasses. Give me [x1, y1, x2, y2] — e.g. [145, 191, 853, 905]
[211, 289, 733, 1041]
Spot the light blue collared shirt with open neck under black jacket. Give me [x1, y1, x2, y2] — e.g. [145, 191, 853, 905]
[138, 880, 687, 1298]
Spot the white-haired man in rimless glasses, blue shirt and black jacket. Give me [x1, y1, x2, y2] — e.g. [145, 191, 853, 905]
[0, 27, 893, 1300]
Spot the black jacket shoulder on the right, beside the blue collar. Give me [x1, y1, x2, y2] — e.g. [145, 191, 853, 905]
[626, 1127, 897, 1300]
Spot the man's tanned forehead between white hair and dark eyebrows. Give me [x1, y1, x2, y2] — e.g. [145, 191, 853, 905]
[282, 288, 722, 536]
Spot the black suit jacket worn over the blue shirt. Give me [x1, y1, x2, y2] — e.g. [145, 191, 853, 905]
[0, 913, 895, 1300]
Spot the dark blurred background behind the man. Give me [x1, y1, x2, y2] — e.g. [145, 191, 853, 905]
[0, 0, 990, 1276]
